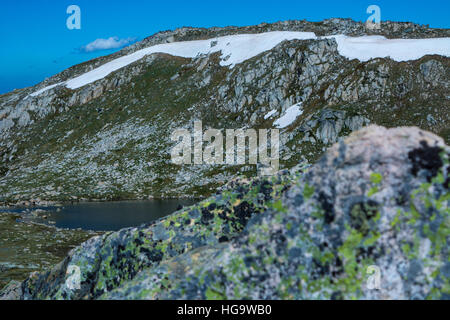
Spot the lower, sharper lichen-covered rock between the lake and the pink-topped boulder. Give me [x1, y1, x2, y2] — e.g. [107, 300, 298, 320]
[4, 166, 301, 299]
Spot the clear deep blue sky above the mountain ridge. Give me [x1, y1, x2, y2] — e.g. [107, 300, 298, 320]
[0, 0, 450, 93]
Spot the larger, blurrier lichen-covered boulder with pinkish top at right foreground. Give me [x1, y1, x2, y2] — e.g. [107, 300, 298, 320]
[102, 126, 450, 299]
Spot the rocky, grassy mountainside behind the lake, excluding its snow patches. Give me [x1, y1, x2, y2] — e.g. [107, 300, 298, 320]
[0, 19, 450, 204]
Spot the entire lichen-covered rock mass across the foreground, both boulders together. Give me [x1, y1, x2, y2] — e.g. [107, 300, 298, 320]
[0, 126, 450, 299]
